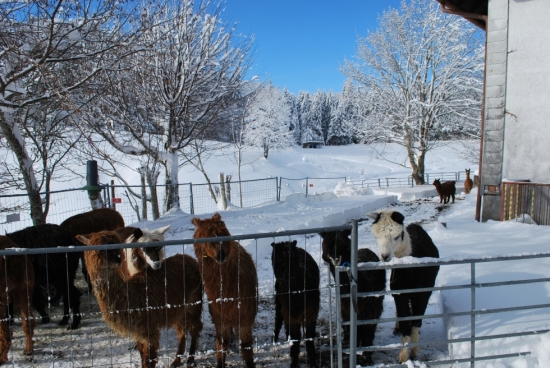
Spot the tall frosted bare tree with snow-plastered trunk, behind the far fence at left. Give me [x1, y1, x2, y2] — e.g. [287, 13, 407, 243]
[90, 0, 250, 210]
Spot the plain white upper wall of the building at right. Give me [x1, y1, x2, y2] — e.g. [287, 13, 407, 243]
[502, 0, 550, 183]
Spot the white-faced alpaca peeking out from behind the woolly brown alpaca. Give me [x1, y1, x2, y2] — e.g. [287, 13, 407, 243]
[119, 225, 170, 277]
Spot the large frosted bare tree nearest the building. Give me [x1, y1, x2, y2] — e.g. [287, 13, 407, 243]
[342, 0, 484, 184]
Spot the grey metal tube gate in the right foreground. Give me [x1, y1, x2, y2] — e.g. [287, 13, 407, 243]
[331, 237, 550, 368]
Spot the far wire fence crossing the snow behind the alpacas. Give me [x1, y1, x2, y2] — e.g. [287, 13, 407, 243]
[0, 172, 463, 232]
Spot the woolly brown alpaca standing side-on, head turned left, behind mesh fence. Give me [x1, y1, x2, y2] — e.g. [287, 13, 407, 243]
[78, 231, 202, 368]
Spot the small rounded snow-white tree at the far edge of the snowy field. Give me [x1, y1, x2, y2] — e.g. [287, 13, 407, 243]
[244, 83, 294, 159]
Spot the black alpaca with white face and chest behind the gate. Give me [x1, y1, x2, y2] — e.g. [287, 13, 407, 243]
[367, 211, 439, 363]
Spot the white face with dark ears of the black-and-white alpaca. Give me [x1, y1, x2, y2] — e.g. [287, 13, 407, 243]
[367, 211, 411, 262]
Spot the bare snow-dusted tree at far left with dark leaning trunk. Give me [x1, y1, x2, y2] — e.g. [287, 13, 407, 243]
[0, 0, 142, 224]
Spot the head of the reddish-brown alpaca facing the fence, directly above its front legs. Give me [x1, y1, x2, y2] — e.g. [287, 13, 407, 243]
[191, 213, 232, 264]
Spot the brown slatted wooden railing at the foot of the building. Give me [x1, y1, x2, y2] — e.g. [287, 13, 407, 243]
[500, 181, 550, 225]
